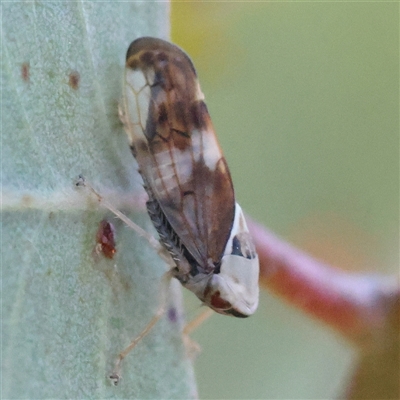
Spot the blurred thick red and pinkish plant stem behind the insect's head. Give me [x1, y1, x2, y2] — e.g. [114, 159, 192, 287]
[248, 220, 399, 346]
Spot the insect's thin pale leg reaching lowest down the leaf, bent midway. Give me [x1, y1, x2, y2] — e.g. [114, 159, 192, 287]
[109, 270, 173, 386]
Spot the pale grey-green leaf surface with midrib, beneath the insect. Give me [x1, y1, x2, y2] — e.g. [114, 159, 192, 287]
[1, 2, 196, 399]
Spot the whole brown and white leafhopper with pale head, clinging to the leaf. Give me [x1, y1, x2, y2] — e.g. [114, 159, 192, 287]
[81, 37, 259, 384]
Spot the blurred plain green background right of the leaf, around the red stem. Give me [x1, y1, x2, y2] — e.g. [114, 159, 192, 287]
[171, 2, 399, 399]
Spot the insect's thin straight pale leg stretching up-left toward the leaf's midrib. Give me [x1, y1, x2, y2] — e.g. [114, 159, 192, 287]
[76, 175, 166, 258]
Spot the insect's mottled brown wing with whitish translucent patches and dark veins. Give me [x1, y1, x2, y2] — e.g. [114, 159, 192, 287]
[123, 38, 235, 272]
